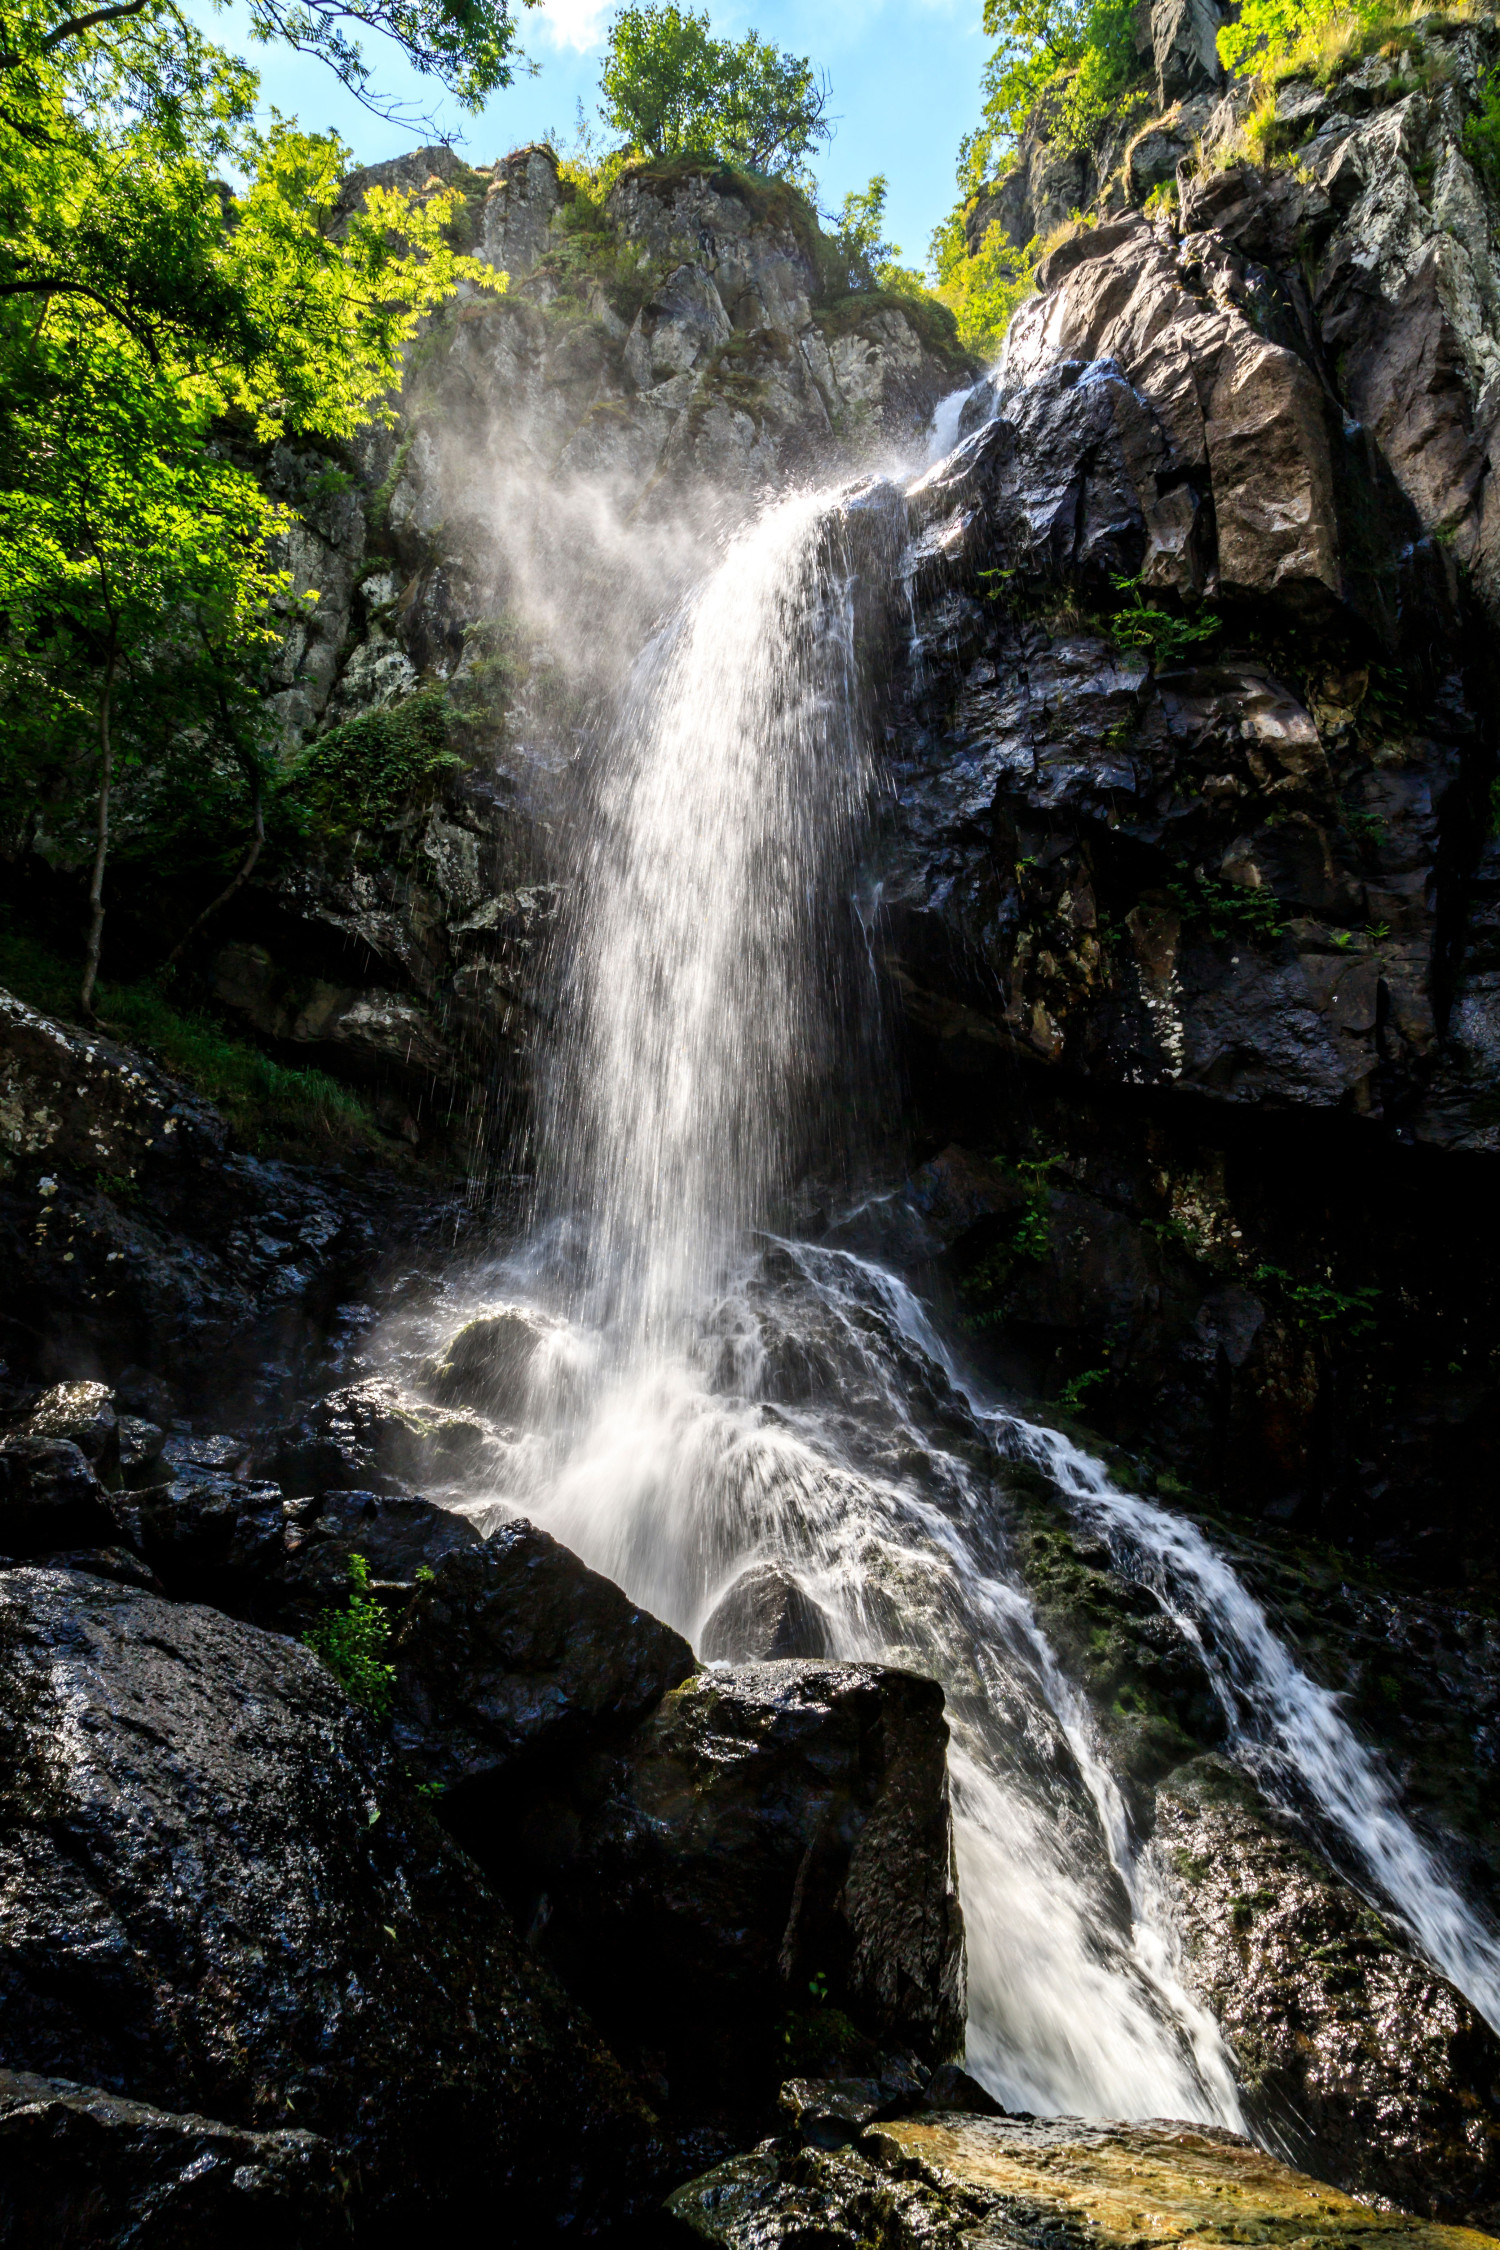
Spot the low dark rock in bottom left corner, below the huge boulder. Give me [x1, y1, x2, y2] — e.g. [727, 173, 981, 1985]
[0, 2070, 353, 2250]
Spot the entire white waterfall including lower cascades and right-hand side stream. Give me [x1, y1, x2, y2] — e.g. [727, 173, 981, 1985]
[452, 434, 1500, 2129]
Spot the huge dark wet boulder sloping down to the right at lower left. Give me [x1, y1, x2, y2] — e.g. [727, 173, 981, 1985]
[0, 1571, 645, 2246]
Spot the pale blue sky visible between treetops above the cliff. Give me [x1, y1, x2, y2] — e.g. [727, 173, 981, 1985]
[193, 0, 985, 266]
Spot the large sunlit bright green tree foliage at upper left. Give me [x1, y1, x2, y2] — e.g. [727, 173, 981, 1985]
[0, 5, 495, 1010]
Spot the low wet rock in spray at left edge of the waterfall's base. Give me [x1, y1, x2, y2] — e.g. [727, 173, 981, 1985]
[265, 1375, 495, 1496]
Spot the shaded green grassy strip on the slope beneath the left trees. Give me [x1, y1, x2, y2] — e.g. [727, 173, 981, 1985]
[0, 927, 380, 1161]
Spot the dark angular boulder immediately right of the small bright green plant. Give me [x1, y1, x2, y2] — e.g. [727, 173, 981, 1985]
[391, 1519, 695, 1791]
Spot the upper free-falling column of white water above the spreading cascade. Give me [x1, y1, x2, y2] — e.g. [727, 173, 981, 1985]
[544, 495, 875, 1352]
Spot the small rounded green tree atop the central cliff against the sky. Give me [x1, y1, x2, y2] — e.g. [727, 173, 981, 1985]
[600, 5, 832, 178]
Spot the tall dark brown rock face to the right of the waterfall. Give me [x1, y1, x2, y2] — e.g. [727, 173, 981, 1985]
[882, 61, 1500, 1577]
